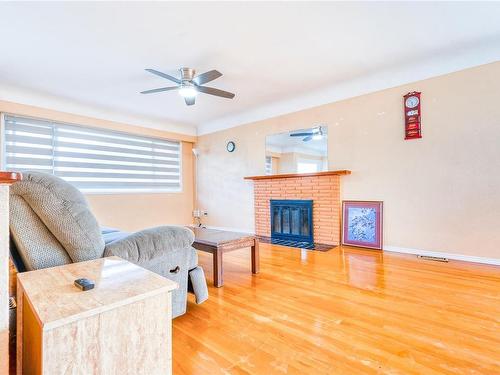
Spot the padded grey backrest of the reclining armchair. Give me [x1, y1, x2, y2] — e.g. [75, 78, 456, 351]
[10, 172, 104, 270]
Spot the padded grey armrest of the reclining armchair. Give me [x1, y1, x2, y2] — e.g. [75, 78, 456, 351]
[104, 226, 194, 264]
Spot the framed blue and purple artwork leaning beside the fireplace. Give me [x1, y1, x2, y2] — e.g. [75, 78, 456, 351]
[342, 201, 383, 250]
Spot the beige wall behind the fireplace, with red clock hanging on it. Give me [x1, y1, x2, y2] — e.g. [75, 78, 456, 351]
[198, 62, 500, 258]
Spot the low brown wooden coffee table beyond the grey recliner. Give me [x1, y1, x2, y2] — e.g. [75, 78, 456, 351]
[190, 227, 259, 288]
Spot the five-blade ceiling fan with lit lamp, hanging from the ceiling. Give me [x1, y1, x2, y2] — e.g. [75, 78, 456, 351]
[141, 68, 234, 105]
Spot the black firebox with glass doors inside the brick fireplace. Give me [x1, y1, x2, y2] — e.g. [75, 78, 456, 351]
[271, 199, 313, 243]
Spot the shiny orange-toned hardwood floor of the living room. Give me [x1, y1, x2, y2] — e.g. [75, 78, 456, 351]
[173, 244, 500, 375]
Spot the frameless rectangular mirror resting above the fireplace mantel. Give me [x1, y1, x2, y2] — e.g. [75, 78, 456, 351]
[265, 125, 328, 175]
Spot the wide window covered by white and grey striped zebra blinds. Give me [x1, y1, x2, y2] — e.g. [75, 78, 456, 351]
[2, 115, 181, 193]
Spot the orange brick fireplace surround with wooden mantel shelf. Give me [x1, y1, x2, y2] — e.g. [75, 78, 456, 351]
[246, 170, 351, 245]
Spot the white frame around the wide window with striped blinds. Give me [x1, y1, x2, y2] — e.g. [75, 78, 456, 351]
[0, 112, 184, 195]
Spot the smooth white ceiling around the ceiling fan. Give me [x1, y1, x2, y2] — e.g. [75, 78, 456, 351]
[0, 2, 500, 134]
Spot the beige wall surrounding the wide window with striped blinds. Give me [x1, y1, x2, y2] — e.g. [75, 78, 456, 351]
[0, 101, 196, 231]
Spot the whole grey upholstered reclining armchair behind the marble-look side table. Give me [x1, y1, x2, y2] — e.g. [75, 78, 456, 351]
[10, 172, 208, 317]
